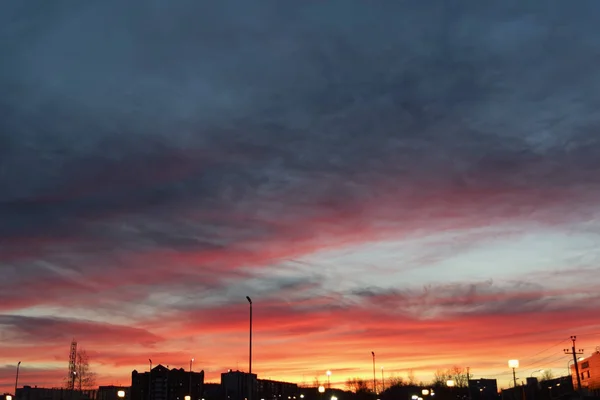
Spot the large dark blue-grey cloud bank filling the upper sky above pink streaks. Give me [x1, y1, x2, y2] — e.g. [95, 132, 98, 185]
[0, 0, 600, 268]
